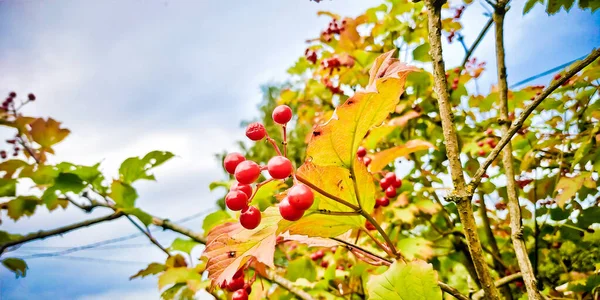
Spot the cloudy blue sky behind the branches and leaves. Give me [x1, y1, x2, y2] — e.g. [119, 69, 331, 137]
[0, 0, 600, 299]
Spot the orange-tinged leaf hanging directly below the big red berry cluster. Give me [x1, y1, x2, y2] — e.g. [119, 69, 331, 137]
[202, 207, 281, 285]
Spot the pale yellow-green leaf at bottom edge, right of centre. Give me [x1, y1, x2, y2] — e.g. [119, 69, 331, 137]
[367, 260, 442, 300]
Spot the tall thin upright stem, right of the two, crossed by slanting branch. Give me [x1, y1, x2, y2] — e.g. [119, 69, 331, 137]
[492, 0, 542, 300]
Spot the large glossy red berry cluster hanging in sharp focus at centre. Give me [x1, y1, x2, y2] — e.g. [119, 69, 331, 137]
[223, 105, 314, 229]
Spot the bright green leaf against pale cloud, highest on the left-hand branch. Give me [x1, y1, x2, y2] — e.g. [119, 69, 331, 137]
[119, 151, 174, 184]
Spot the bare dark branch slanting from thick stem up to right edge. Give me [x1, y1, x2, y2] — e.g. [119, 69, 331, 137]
[468, 49, 600, 191]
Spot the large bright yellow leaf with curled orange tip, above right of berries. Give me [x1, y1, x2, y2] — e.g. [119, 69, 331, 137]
[307, 51, 416, 169]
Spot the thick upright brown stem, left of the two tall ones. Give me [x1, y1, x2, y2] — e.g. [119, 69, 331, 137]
[425, 0, 500, 300]
